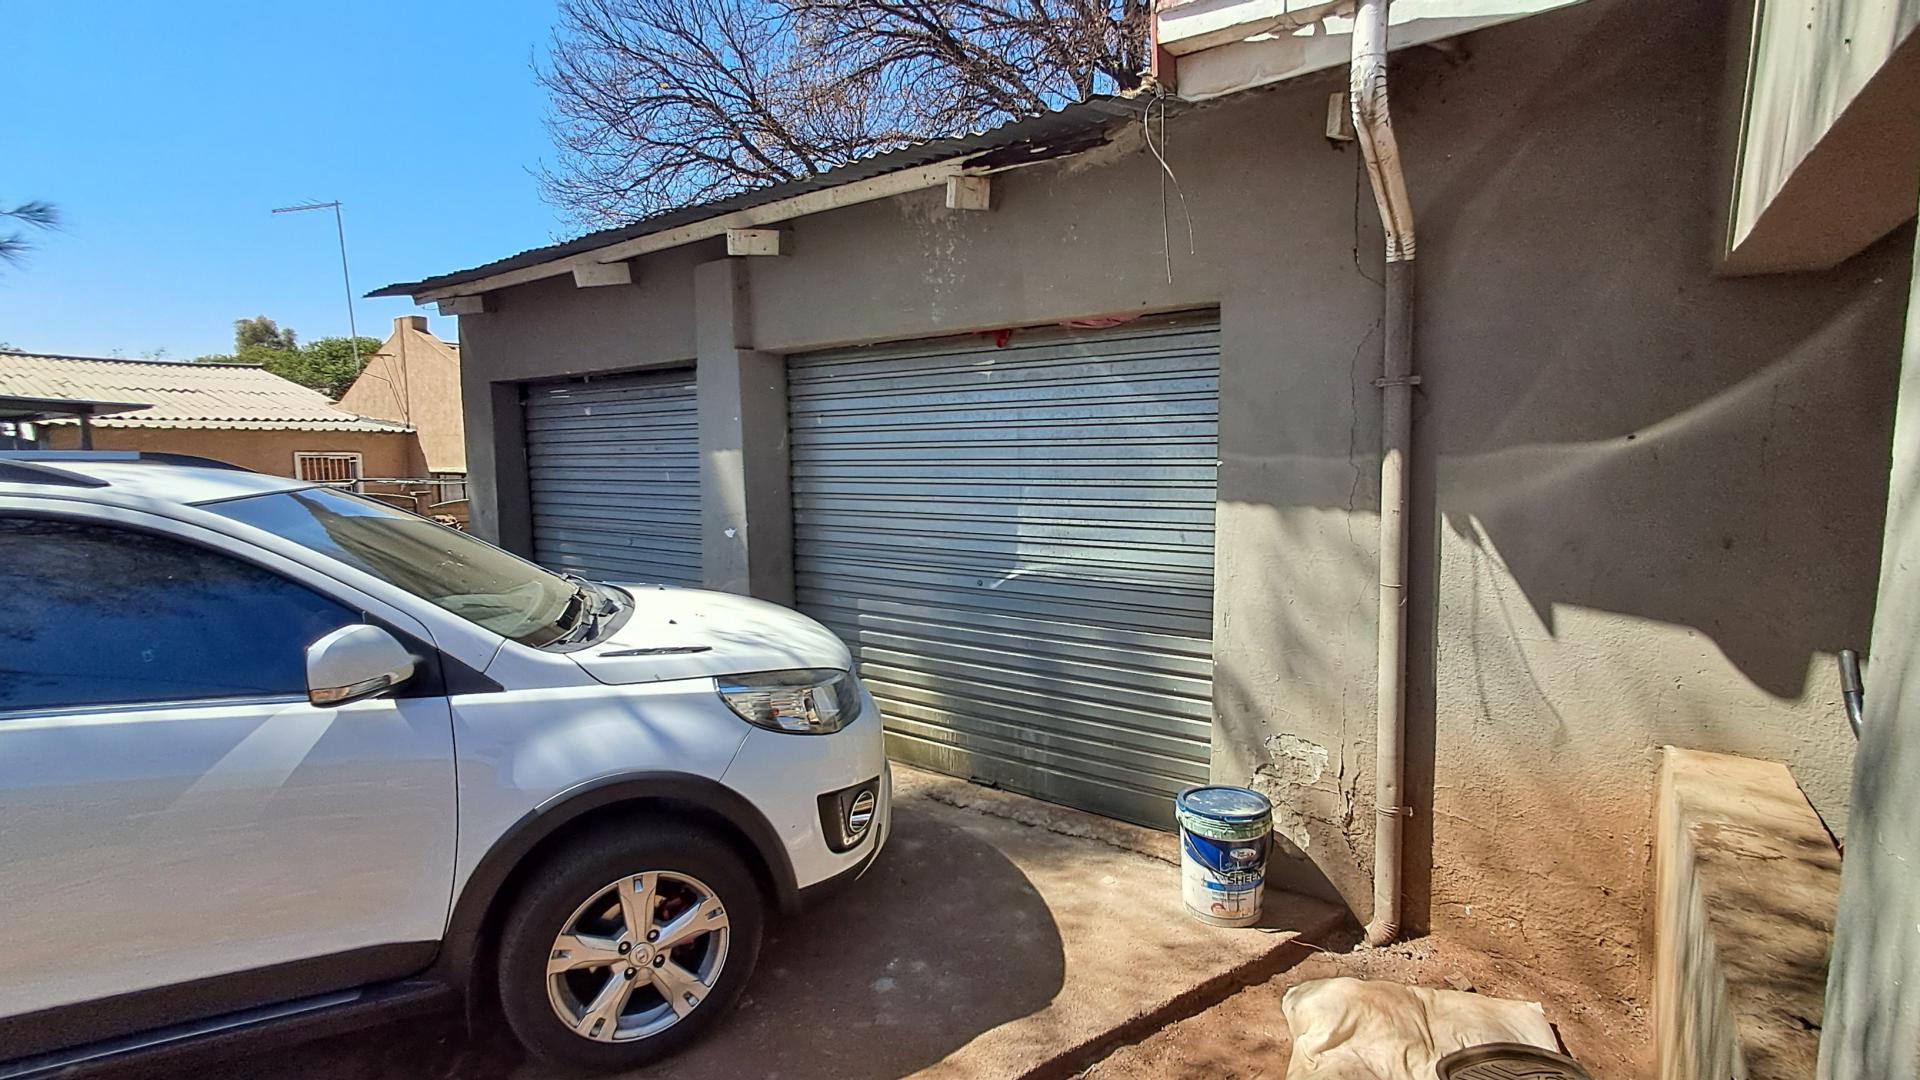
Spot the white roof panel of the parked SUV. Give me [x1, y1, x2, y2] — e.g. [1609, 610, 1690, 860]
[0, 450, 315, 505]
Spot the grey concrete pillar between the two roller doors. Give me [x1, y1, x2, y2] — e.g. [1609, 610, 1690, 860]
[693, 259, 793, 603]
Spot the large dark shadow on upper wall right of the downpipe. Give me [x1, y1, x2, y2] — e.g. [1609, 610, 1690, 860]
[1396, 4, 1910, 698]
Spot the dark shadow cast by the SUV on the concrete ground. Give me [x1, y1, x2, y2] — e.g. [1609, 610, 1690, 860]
[234, 807, 1066, 1080]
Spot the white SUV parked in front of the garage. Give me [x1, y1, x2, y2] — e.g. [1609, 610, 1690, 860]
[0, 452, 889, 1076]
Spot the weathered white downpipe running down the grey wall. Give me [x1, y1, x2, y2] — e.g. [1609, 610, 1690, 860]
[1348, 0, 1415, 945]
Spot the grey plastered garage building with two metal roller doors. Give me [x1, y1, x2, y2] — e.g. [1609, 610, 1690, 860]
[376, 0, 1920, 1074]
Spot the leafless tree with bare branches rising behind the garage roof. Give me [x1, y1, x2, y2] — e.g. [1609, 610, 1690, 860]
[536, 0, 1148, 225]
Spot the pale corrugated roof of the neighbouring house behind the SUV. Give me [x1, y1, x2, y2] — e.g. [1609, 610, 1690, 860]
[0, 352, 411, 432]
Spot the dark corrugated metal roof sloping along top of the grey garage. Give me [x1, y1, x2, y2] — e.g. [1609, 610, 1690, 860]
[367, 94, 1144, 296]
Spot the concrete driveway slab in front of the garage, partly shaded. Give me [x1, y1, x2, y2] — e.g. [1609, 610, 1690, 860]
[221, 769, 1340, 1080]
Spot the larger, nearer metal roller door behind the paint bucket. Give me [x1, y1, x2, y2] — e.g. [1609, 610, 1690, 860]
[787, 319, 1219, 828]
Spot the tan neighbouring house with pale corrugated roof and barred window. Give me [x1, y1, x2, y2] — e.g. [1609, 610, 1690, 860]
[0, 354, 424, 474]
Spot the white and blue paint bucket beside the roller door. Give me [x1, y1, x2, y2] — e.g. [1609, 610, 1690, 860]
[1173, 784, 1273, 926]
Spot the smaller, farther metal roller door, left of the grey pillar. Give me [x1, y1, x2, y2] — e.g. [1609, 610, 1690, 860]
[524, 371, 701, 584]
